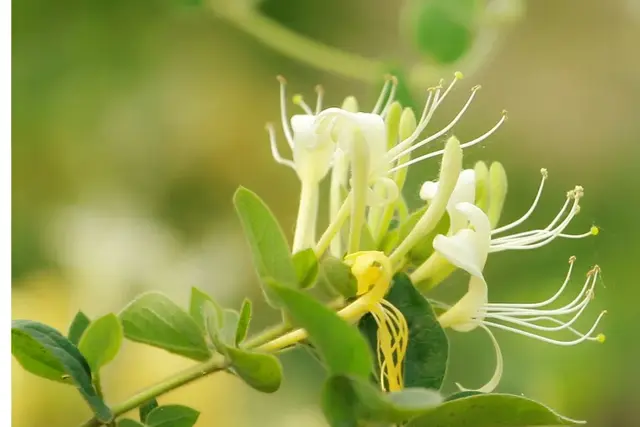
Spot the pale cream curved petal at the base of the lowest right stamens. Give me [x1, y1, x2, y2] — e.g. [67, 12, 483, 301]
[438, 276, 489, 332]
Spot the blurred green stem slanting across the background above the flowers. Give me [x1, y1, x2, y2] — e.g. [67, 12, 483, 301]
[211, 6, 386, 83]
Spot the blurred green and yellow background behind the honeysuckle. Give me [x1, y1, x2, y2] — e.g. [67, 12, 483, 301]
[12, 0, 640, 427]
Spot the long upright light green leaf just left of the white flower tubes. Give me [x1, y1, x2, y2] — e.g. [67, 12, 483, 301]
[233, 187, 298, 306]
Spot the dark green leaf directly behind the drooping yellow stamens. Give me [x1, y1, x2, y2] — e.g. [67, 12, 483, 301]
[360, 273, 449, 390]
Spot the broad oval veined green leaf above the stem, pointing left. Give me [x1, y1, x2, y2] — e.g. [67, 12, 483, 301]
[120, 292, 211, 361]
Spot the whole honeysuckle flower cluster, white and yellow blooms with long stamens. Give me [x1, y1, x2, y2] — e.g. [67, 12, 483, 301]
[267, 73, 604, 392]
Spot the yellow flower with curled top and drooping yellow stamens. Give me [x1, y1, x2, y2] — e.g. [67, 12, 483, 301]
[345, 251, 409, 391]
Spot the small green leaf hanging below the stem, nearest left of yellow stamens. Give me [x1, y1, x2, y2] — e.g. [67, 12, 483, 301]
[227, 347, 282, 393]
